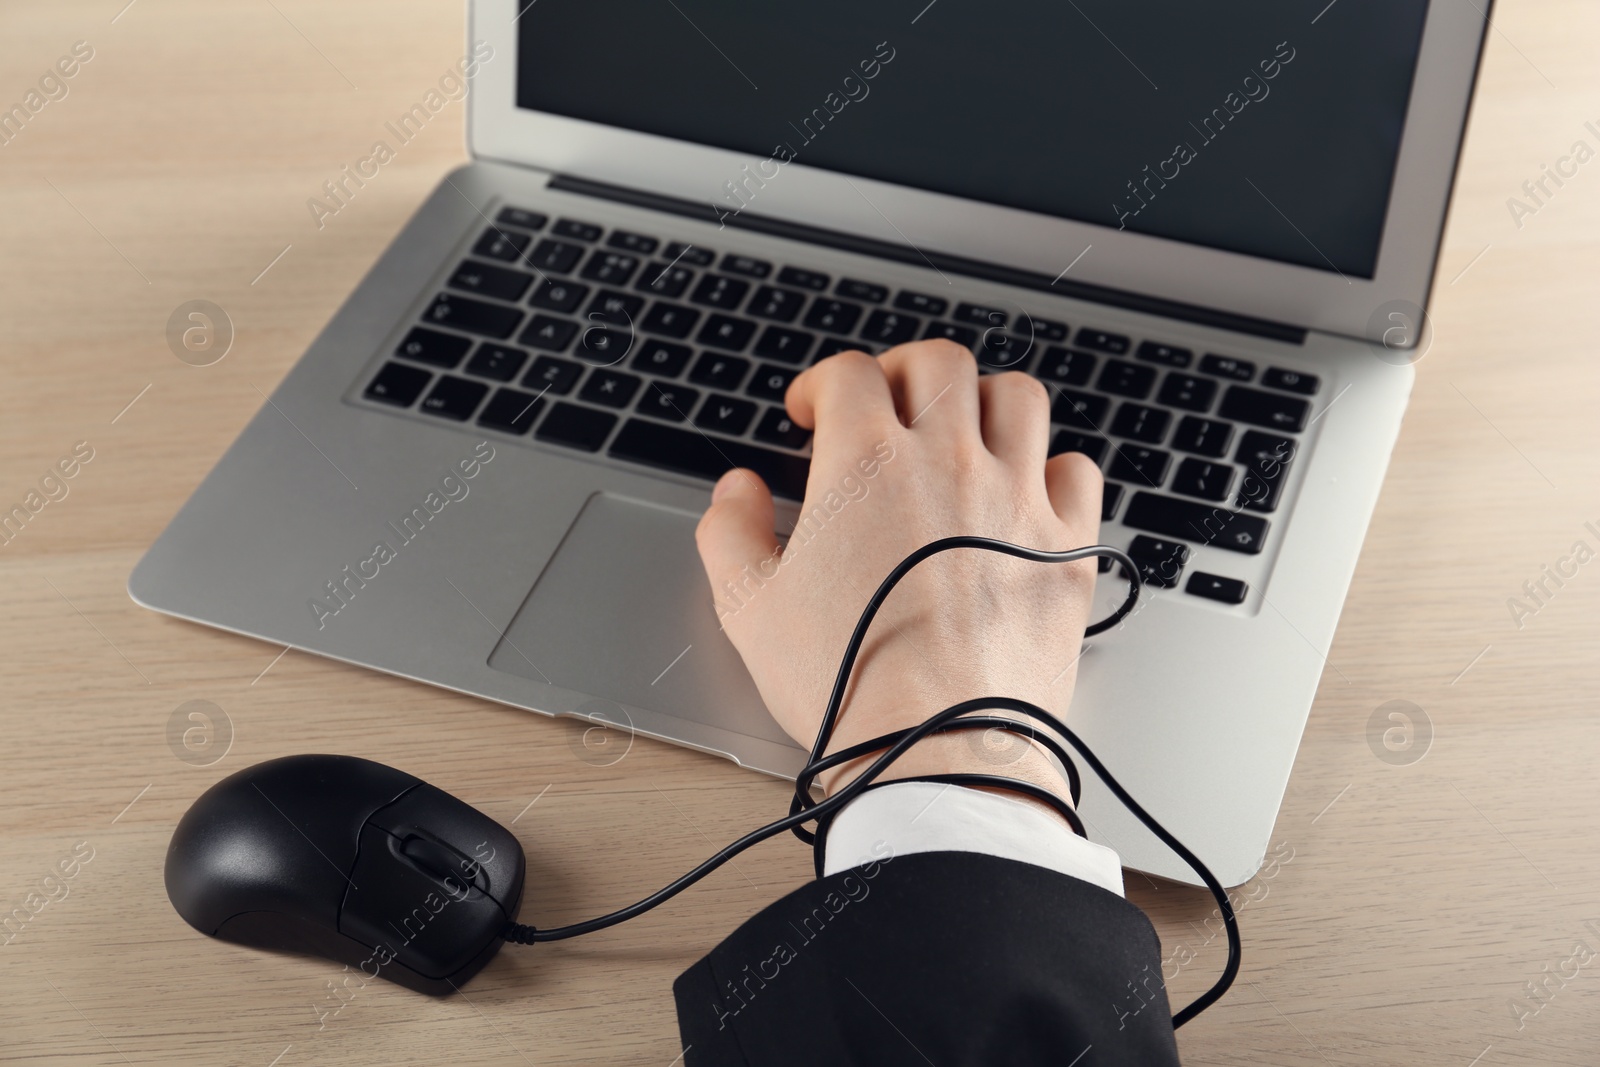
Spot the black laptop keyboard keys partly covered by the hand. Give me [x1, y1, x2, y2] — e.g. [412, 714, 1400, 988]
[362, 208, 1320, 603]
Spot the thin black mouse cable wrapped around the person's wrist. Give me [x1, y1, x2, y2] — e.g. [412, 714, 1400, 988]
[502, 536, 1242, 1029]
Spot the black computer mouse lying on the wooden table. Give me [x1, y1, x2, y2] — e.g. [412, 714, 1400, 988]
[166, 755, 525, 993]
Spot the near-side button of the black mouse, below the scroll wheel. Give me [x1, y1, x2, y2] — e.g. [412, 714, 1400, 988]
[339, 825, 507, 979]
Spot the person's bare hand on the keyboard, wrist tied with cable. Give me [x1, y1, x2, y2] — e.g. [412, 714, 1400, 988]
[696, 341, 1101, 806]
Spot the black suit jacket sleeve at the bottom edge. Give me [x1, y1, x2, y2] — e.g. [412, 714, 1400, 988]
[674, 853, 1178, 1067]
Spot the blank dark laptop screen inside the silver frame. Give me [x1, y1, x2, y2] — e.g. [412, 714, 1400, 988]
[517, 0, 1427, 278]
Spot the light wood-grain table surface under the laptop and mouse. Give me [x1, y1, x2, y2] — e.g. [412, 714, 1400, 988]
[0, 0, 1600, 1067]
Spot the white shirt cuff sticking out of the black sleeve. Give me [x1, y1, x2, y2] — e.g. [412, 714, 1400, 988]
[822, 782, 1123, 896]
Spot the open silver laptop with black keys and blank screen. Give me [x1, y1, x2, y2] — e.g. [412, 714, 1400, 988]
[128, 0, 1485, 885]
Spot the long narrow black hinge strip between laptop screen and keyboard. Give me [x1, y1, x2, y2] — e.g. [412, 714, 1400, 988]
[550, 174, 1306, 344]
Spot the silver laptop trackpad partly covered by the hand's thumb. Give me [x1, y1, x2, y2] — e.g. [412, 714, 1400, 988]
[490, 493, 794, 745]
